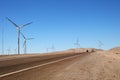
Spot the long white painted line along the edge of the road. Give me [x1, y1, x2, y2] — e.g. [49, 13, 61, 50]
[0, 55, 79, 78]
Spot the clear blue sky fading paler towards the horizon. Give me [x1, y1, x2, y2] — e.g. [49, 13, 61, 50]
[0, 0, 120, 54]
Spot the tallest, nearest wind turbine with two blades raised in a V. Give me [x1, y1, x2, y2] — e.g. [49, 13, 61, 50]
[6, 18, 32, 54]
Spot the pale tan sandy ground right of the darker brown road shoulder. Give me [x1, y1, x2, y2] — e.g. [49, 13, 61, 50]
[54, 52, 120, 80]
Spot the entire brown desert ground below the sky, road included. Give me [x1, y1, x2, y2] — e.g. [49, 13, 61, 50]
[0, 47, 120, 80]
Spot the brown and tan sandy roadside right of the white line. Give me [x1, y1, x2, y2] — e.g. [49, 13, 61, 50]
[0, 52, 120, 80]
